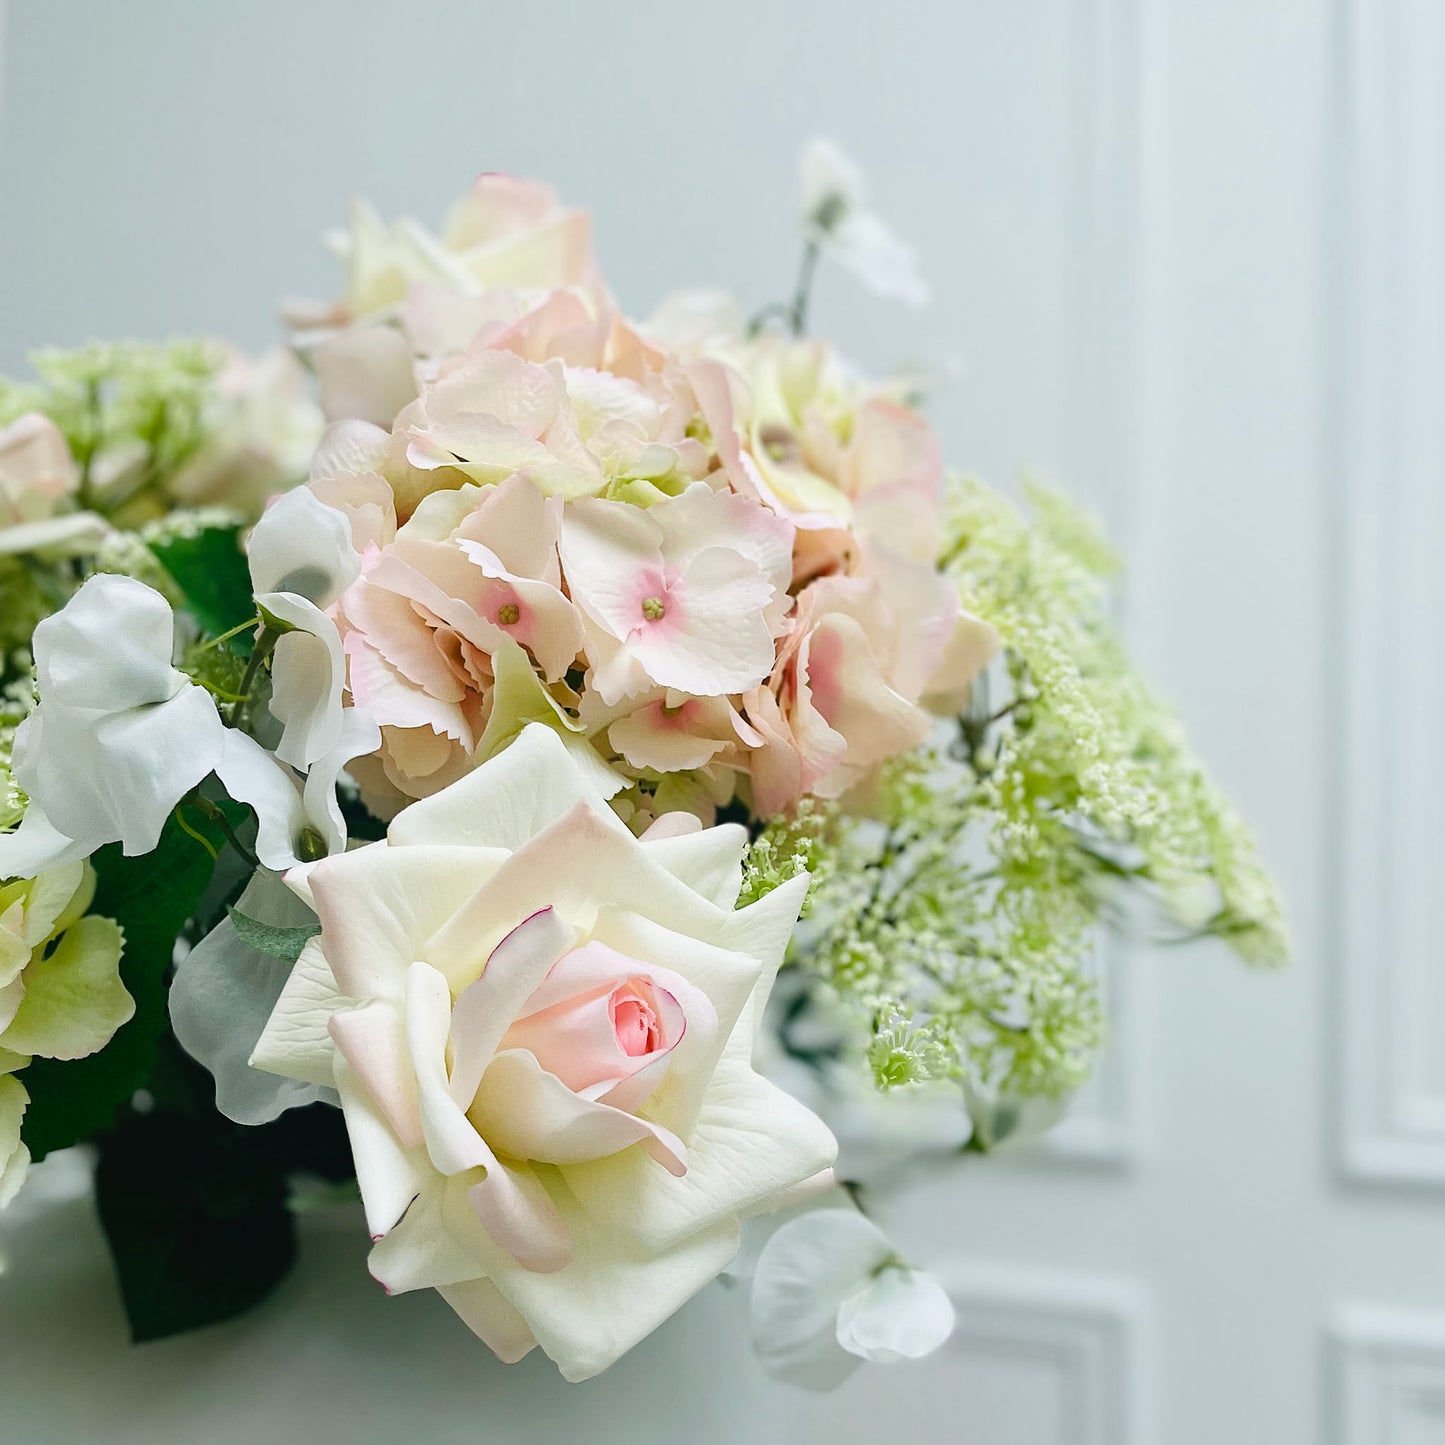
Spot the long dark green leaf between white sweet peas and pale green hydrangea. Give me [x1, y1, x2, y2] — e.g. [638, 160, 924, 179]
[20, 805, 234, 1159]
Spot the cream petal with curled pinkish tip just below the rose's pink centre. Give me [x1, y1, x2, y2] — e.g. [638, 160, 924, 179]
[468, 1049, 688, 1175]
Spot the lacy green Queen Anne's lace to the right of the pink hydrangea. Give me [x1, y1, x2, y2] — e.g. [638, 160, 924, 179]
[744, 483, 1287, 1138]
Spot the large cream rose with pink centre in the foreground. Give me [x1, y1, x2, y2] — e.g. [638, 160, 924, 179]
[251, 727, 835, 1380]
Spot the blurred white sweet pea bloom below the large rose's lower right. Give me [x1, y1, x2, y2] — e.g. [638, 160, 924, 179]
[750, 1207, 954, 1390]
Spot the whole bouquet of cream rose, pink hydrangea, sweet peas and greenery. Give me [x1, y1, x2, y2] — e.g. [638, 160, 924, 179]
[0, 143, 1285, 1387]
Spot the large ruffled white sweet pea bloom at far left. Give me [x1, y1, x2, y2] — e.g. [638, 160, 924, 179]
[0, 574, 336, 877]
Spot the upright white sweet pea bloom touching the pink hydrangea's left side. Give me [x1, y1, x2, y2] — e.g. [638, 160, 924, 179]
[247, 487, 361, 769]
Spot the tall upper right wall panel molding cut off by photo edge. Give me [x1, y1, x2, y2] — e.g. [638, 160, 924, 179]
[1328, 0, 1445, 1186]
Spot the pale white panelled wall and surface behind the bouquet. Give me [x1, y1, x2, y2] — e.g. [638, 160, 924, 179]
[0, 0, 1445, 1445]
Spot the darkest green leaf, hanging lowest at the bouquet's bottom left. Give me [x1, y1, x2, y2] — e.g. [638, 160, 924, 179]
[95, 1113, 296, 1344]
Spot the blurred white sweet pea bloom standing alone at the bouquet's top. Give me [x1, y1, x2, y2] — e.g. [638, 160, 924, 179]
[801, 136, 929, 306]
